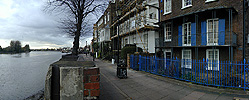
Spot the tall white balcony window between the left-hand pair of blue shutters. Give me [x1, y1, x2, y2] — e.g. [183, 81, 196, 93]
[182, 22, 191, 46]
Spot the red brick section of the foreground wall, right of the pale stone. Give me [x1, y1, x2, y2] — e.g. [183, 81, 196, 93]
[83, 67, 100, 99]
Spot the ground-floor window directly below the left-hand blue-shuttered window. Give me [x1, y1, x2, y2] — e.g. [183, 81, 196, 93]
[182, 49, 192, 69]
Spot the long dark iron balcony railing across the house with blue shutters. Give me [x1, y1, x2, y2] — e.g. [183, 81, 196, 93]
[155, 31, 237, 47]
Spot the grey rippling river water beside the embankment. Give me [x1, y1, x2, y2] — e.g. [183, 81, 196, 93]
[0, 51, 63, 100]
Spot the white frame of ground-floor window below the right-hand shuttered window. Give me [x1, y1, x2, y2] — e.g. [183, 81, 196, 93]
[206, 49, 220, 71]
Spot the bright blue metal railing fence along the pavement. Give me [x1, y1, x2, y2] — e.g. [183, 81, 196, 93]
[130, 55, 249, 90]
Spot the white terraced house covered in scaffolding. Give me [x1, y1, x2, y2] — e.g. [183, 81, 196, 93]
[111, 0, 159, 53]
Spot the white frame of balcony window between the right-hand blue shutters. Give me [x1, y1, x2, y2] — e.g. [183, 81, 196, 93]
[207, 18, 219, 45]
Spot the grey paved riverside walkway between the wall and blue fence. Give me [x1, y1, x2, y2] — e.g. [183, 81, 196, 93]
[80, 55, 249, 100]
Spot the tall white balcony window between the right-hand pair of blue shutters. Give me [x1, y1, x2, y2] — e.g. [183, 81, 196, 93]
[207, 19, 219, 45]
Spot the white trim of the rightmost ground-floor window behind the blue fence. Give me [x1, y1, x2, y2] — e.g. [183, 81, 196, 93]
[206, 49, 220, 71]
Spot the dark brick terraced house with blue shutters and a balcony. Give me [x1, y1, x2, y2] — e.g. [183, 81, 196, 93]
[156, 0, 249, 70]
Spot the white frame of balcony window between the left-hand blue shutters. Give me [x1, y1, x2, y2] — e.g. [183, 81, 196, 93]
[182, 22, 191, 46]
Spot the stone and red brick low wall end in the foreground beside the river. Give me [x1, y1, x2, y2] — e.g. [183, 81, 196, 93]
[44, 55, 100, 100]
